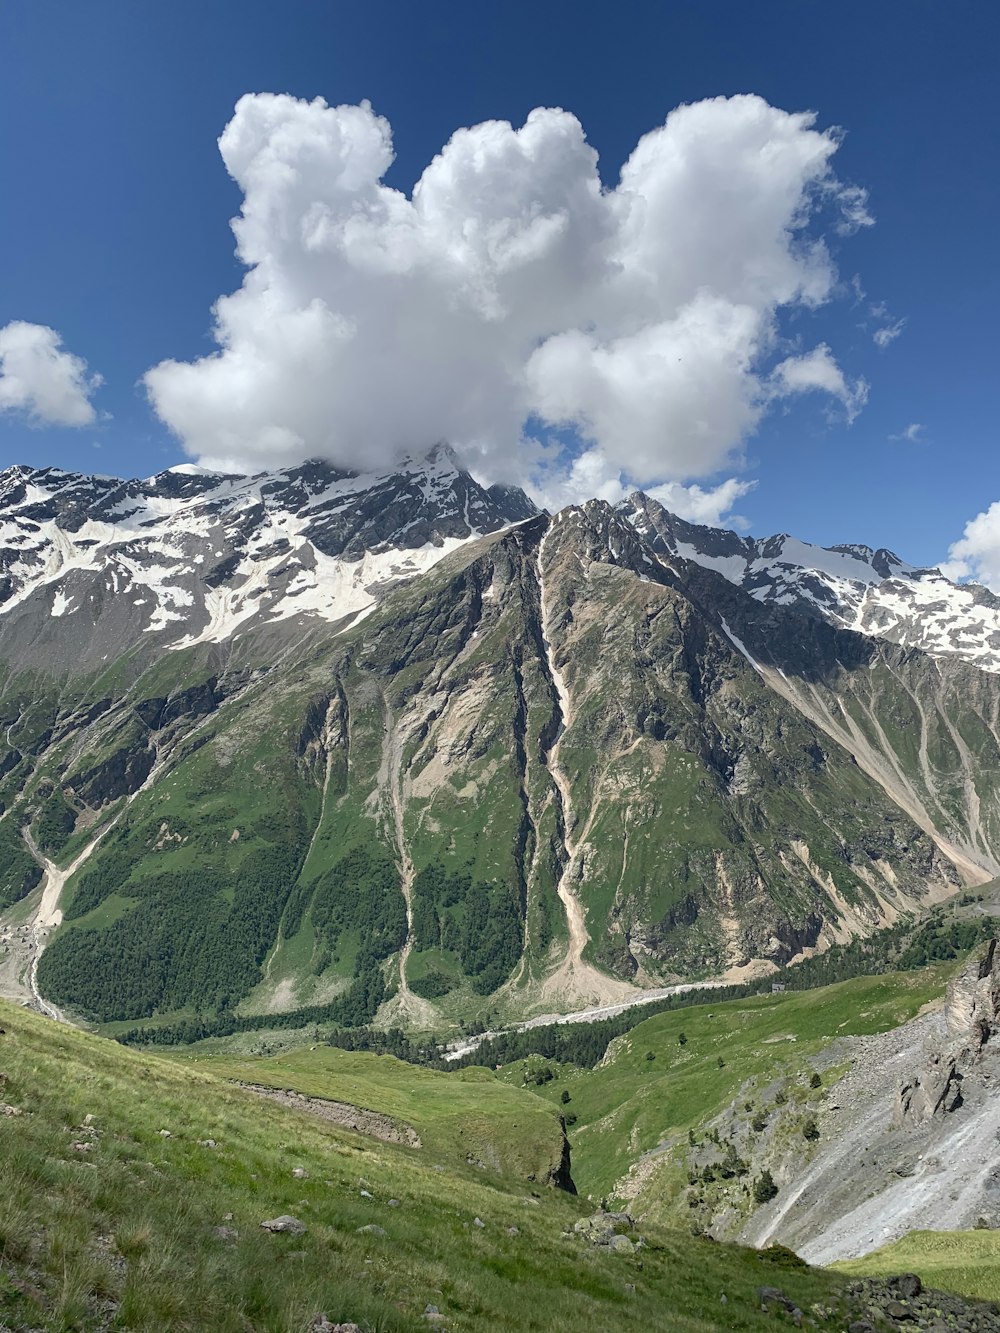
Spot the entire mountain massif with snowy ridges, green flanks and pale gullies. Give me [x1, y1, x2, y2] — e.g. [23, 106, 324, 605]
[0, 448, 1000, 1040]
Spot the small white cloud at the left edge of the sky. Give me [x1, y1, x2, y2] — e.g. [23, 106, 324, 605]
[0, 320, 103, 425]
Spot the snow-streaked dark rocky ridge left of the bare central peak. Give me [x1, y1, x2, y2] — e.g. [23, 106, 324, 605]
[0, 445, 536, 660]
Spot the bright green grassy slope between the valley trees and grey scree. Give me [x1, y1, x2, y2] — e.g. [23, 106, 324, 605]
[520, 968, 947, 1220]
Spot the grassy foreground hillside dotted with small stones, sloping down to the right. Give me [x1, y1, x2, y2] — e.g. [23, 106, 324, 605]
[0, 1005, 885, 1333]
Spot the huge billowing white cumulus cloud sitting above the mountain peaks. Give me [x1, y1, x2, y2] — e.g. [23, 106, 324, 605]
[145, 93, 871, 501]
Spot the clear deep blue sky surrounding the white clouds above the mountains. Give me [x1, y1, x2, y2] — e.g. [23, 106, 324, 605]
[0, 0, 1000, 568]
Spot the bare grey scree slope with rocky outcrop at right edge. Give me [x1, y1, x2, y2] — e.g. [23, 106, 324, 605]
[739, 940, 1000, 1264]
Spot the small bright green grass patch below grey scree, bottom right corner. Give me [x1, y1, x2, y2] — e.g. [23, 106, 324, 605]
[833, 1230, 1000, 1301]
